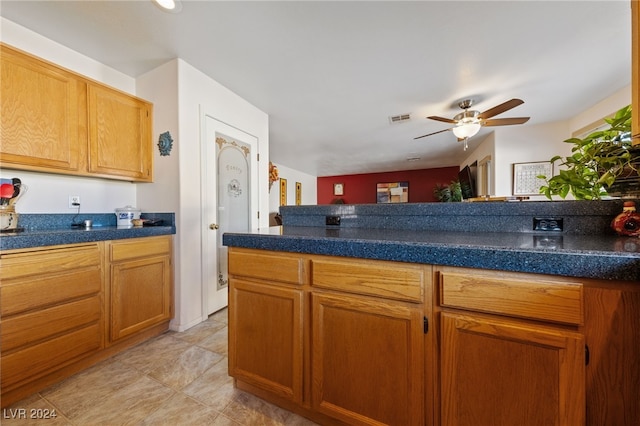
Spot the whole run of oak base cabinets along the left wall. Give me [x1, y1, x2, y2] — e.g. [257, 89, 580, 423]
[0, 235, 173, 407]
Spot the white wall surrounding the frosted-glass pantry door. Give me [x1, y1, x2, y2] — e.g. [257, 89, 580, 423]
[138, 59, 269, 330]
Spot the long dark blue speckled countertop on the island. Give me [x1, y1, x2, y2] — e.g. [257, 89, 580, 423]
[223, 226, 640, 282]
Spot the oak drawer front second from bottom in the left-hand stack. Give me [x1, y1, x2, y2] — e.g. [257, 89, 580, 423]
[0, 296, 102, 354]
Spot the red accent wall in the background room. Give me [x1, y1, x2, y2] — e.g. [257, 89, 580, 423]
[317, 166, 460, 204]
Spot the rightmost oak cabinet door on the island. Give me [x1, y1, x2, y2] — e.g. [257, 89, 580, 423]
[441, 313, 585, 426]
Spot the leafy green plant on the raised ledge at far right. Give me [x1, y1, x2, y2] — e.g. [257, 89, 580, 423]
[539, 105, 640, 200]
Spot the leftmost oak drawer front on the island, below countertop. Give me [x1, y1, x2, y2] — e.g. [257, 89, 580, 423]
[229, 248, 305, 284]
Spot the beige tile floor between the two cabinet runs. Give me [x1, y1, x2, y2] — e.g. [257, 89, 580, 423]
[0, 309, 315, 426]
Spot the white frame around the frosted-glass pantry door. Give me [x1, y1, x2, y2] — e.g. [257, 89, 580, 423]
[199, 105, 260, 321]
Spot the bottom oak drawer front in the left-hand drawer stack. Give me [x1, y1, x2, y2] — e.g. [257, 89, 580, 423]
[0, 324, 102, 391]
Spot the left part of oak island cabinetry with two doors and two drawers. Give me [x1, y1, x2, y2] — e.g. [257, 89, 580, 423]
[229, 247, 430, 425]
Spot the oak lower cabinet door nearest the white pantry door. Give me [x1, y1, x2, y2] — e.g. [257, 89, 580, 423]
[111, 256, 171, 340]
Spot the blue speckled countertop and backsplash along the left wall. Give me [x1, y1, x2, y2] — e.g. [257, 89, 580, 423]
[0, 213, 176, 250]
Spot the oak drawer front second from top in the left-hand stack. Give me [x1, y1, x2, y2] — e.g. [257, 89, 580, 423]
[0, 266, 102, 317]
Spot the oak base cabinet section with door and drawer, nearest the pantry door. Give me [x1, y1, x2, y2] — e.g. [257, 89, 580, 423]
[108, 236, 173, 341]
